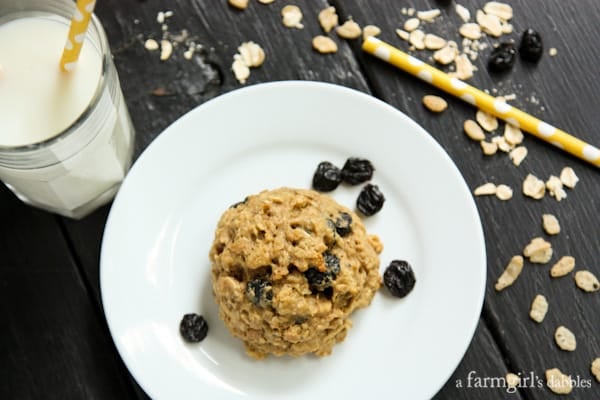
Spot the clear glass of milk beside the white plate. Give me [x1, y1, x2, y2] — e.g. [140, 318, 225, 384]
[0, 0, 134, 218]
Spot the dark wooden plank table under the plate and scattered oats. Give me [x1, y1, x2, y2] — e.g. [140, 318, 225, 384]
[0, 0, 600, 400]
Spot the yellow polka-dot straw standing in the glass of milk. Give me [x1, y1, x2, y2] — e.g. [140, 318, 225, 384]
[60, 0, 96, 71]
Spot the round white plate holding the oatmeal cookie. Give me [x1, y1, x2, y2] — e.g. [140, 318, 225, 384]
[100, 82, 486, 400]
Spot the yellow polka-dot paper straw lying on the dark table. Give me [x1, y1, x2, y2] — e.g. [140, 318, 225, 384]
[362, 37, 600, 167]
